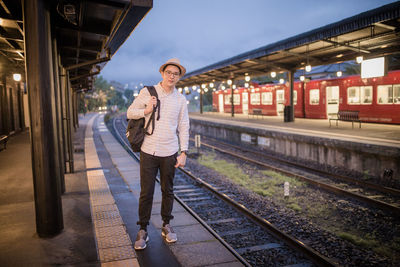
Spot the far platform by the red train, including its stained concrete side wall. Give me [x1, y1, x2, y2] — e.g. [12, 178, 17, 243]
[190, 113, 400, 181]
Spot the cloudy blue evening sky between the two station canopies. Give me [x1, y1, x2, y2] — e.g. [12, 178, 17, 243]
[100, 0, 396, 88]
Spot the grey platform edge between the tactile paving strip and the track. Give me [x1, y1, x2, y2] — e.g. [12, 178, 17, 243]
[85, 116, 242, 266]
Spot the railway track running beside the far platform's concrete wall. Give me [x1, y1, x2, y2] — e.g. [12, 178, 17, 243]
[191, 137, 400, 216]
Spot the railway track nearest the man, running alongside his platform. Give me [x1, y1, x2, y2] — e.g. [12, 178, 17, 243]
[111, 116, 336, 266]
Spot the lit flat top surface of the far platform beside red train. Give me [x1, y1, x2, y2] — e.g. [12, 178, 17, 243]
[189, 110, 400, 147]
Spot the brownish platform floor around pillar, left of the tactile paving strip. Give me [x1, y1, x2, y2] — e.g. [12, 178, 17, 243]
[0, 114, 100, 266]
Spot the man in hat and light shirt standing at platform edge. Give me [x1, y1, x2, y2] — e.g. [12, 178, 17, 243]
[127, 58, 189, 250]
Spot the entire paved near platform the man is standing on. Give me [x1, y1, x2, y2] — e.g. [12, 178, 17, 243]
[0, 114, 243, 267]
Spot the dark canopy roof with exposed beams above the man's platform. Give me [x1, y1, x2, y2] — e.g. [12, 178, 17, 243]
[0, 0, 153, 90]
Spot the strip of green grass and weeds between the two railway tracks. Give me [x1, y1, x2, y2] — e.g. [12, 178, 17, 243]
[197, 152, 400, 258]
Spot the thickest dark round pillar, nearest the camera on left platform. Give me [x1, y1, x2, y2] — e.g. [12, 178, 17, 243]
[23, 0, 64, 237]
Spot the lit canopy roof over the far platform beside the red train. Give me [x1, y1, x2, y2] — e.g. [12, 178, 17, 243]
[177, 1, 400, 87]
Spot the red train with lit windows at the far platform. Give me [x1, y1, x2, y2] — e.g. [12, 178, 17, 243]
[213, 70, 400, 124]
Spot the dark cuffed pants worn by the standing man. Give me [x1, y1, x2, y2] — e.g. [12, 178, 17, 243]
[138, 152, 177, 226]
